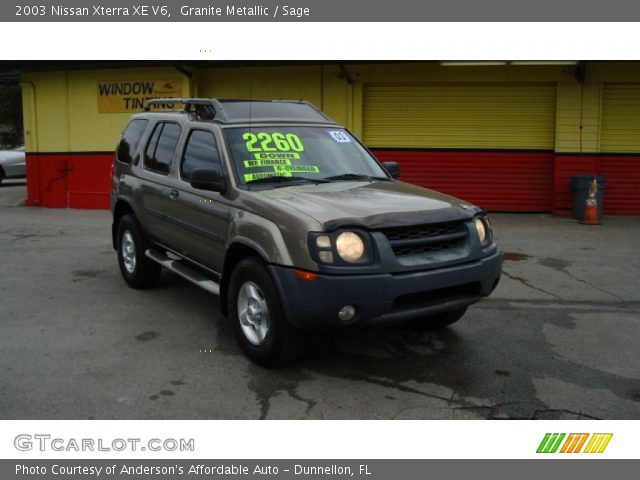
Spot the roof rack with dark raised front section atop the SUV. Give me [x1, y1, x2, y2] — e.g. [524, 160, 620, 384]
[144, 98, 335, 125]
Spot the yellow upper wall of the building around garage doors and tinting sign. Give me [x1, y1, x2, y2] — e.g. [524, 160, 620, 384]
[22, 62, 640, 153]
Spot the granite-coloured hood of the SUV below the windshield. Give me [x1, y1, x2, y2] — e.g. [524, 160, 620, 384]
[255, 181, 480, 231]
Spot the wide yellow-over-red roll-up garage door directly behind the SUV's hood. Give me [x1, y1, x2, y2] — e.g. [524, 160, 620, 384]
[363, 83, 556, 211]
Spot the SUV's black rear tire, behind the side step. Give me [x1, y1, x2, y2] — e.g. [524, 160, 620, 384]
[116, 215, 162, 288]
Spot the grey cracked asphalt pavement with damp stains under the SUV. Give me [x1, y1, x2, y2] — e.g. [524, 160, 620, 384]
[0, 183, 640, 419]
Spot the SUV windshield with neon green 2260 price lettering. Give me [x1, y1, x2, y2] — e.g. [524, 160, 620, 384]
[225, 127, 388, 187]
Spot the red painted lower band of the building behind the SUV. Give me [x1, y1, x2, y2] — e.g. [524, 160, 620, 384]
[27, 150, 640, 215]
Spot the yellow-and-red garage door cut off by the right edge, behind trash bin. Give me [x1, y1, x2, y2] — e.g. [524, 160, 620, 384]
[598, 83, 640, 214]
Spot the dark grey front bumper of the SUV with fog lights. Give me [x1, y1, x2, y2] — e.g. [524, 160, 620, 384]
[269, 251, 502, 329]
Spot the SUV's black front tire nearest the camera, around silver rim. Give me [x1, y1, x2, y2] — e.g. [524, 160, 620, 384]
[227, 257, 303, 367]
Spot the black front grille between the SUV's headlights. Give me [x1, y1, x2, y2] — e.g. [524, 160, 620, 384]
[382, 222, 467, 257]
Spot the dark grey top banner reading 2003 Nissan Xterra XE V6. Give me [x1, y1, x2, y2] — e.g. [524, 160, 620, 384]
[6, 0, 640, 21]
